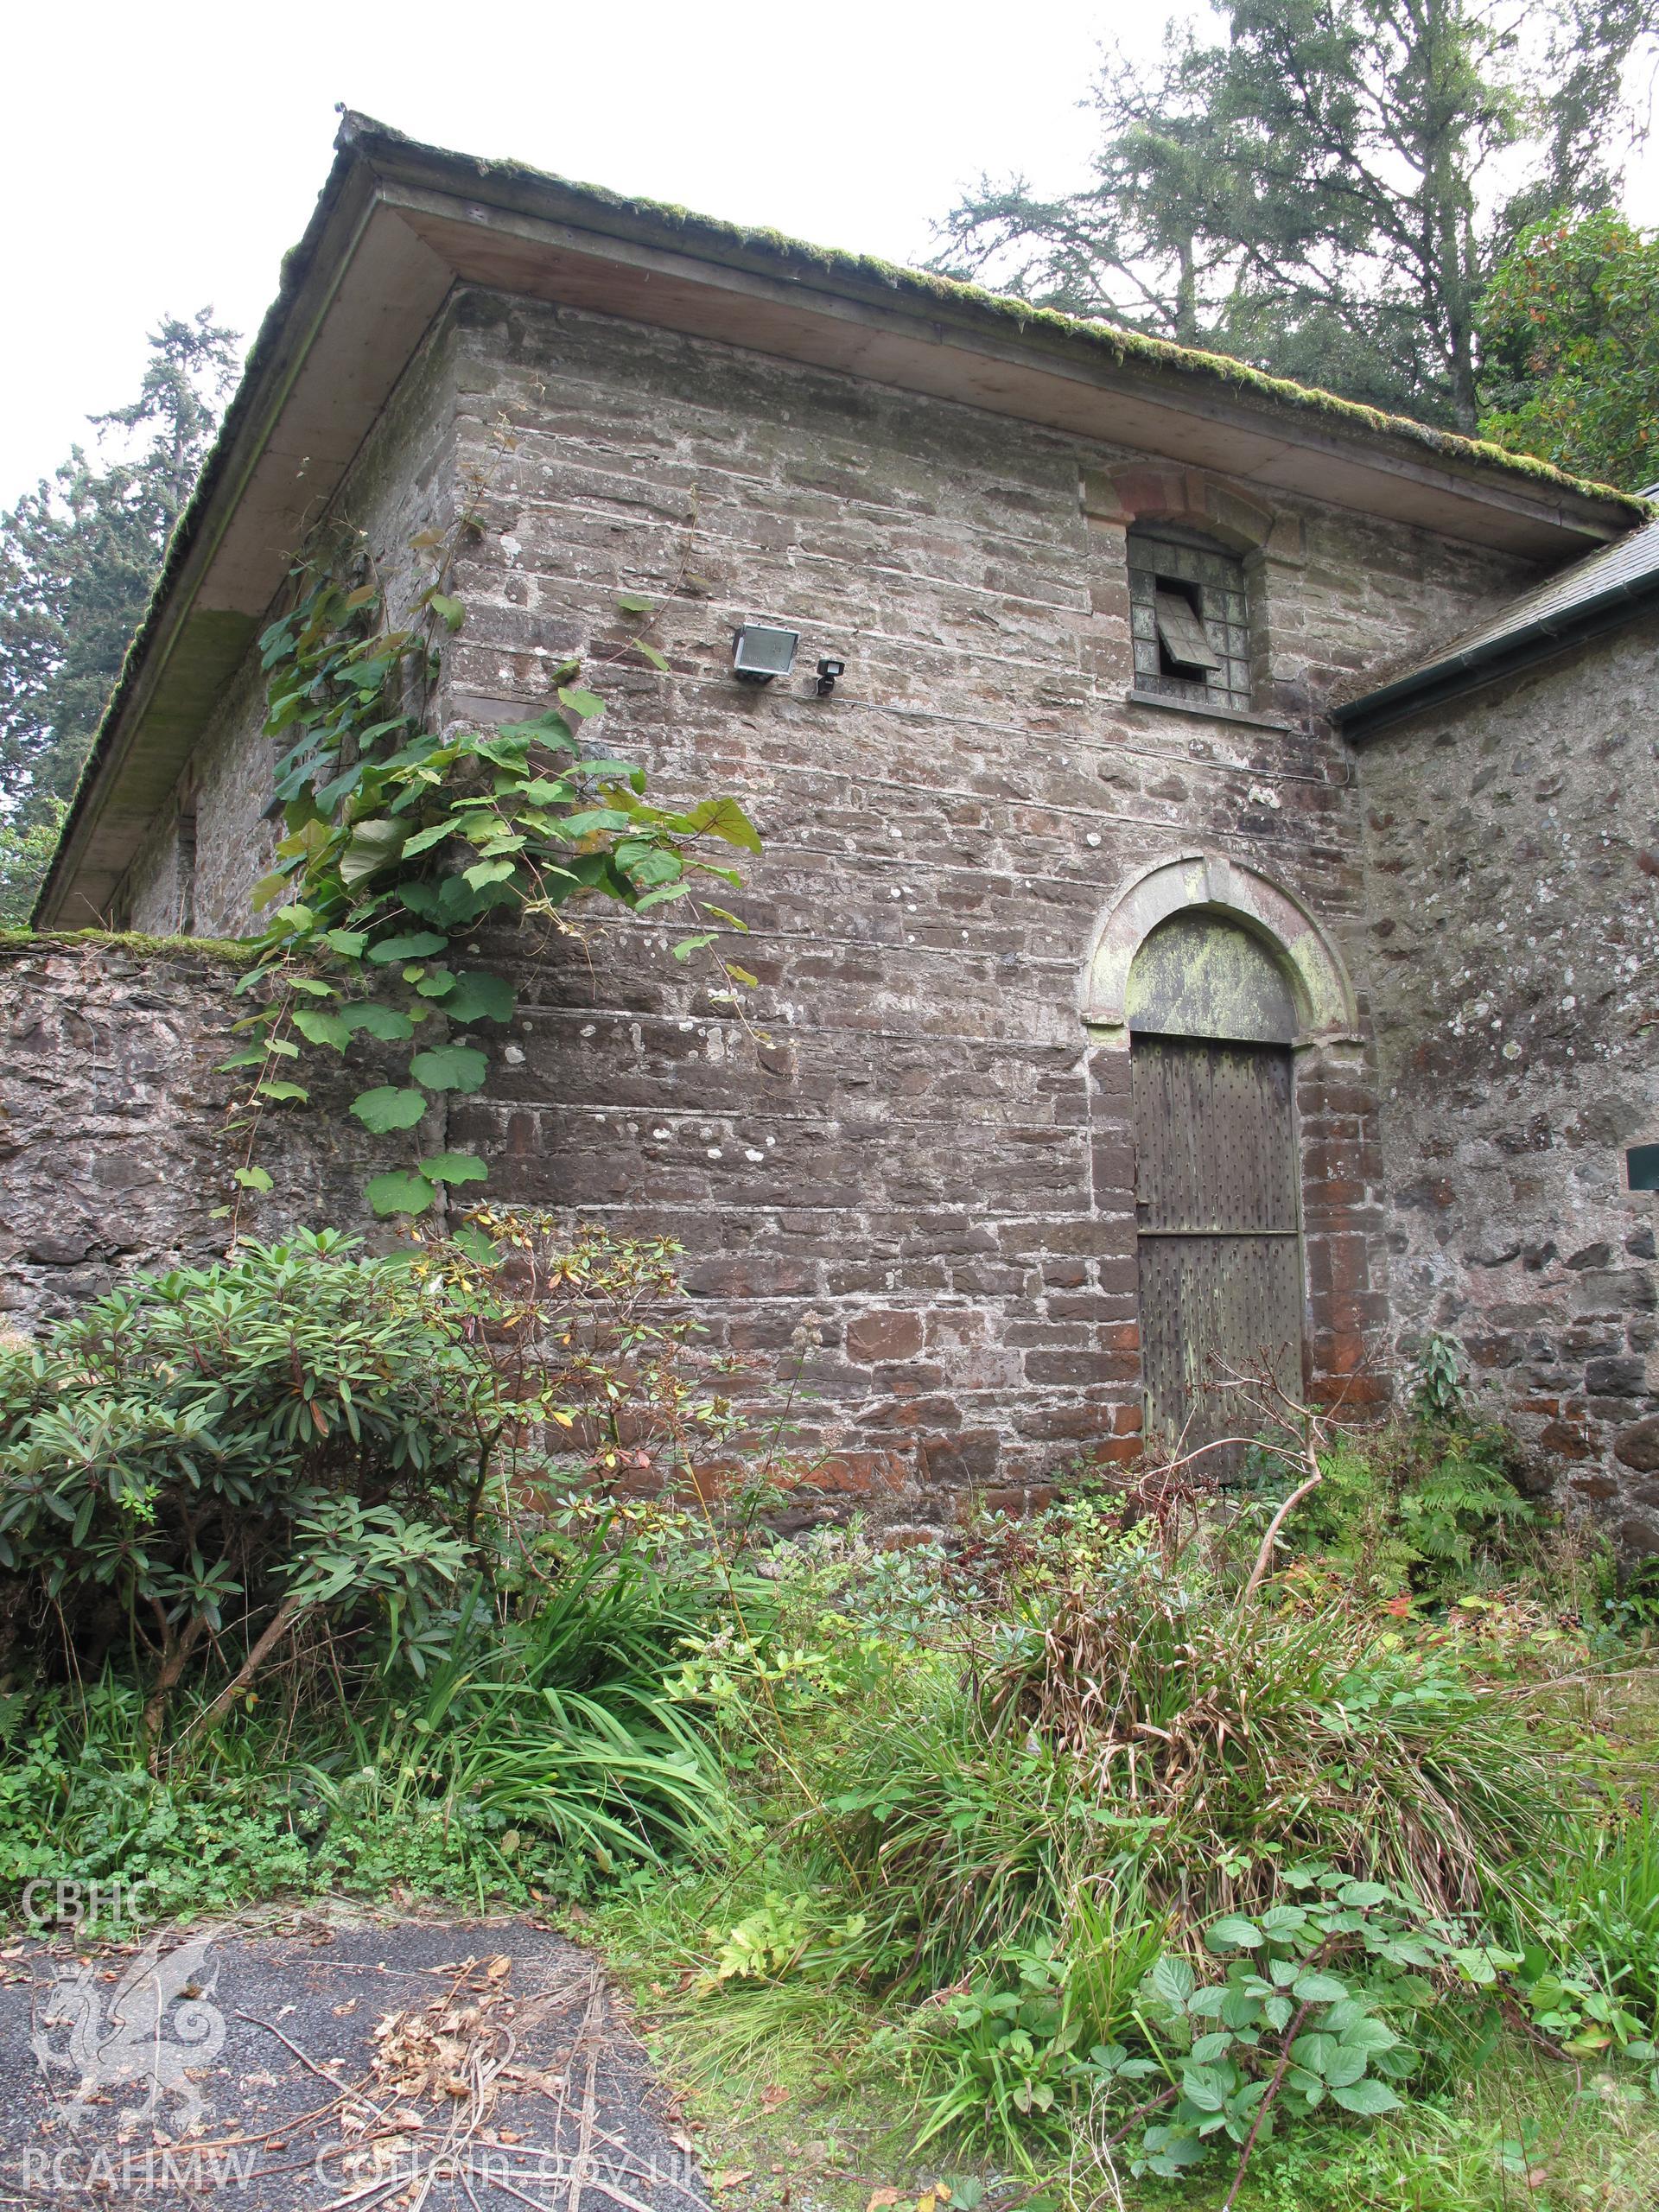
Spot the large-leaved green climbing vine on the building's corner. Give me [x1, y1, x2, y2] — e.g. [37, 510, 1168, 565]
[224, 524, 761, 1214]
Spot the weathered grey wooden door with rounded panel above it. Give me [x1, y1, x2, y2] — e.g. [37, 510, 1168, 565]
[1126, 912, 1303, 1458]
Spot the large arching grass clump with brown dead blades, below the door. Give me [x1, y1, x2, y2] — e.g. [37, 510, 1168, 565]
[984, 1561, 1557, 1916]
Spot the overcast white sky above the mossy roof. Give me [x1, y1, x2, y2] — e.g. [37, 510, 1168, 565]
[0, 0, 1659, 506]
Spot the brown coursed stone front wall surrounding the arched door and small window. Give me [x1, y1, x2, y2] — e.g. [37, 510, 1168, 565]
[416, 294, 1522, 1513]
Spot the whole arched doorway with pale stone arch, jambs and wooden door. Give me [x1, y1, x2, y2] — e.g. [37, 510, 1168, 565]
[1079, 852, 1385, 1442]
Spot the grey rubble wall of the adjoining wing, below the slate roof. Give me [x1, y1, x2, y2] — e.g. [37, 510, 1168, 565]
[1360, 617, 1659, 1551]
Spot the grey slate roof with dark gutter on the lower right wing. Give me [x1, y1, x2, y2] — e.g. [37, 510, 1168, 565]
[1334, 511, 1659, 736]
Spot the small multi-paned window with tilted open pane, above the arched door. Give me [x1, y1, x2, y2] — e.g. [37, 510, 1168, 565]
[1128, 524, 1249, 715]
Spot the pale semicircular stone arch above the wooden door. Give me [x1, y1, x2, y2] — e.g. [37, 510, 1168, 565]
[1082, 852, 1358, 1044]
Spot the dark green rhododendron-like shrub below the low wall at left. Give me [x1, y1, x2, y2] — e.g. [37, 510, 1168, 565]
[0, 1230, 498, 1738]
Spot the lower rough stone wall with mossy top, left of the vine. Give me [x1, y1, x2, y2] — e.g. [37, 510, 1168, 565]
[0, 938, 376, 1327]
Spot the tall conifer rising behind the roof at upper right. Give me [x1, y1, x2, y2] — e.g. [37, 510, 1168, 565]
[936, 0, 1659, 429]
